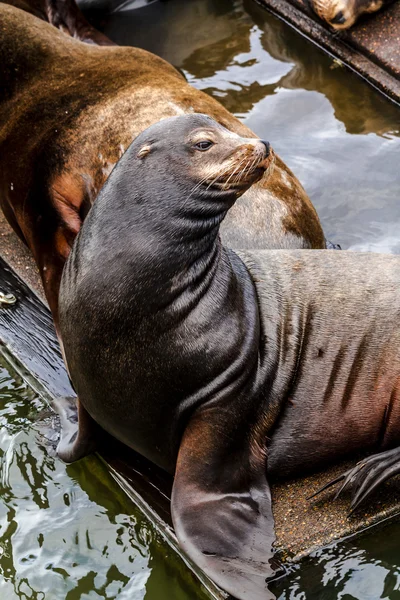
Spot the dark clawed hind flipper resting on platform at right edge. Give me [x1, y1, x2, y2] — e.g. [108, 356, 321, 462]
[311, 447, 400, 514]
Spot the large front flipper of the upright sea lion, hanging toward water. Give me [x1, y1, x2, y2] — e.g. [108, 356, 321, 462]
[172, 413, 275, 600]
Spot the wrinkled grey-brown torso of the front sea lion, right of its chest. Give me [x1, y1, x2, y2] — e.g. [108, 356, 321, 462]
[239, 246, 400, 477]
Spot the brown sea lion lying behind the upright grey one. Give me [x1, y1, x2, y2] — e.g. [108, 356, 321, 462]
[0, 4, 325, 330]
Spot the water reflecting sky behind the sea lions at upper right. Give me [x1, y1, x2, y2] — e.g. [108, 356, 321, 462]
[94, 0, 400, 252]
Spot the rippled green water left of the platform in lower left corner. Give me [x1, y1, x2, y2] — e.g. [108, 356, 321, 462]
[0, 361, 206, 600]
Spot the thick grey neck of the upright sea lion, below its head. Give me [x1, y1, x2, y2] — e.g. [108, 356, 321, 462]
[77, 159, 233, 306]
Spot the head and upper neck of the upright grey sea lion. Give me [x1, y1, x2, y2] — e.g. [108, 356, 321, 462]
[75, 113, 274, 277]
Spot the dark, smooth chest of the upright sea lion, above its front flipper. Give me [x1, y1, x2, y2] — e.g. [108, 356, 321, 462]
[60, 241, 258, 472]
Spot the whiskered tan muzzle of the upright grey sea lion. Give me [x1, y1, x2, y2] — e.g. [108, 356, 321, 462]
[205, 140, 275, 193]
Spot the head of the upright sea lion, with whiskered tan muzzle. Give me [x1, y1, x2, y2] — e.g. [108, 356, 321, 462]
[129, 114, 274, 219]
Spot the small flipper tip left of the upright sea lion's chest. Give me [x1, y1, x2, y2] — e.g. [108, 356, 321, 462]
[54, 397, 99, 463]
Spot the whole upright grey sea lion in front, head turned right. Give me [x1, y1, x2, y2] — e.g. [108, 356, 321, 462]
[60, 115, 400, 600]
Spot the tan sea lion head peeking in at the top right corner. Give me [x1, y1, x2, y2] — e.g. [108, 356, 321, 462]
[311, 0, 383, 30]
